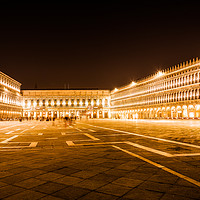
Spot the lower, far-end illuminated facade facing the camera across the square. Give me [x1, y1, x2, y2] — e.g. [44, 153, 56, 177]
[22, 89, 110, 119]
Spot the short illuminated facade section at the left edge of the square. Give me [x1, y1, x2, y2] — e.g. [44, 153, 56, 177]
[0, 72, 22, 120]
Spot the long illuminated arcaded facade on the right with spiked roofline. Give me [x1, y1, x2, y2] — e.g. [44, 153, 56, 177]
[111, 58, 200, 119]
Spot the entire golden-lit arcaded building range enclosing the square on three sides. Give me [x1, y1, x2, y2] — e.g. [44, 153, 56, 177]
[0, 58, 200, 120]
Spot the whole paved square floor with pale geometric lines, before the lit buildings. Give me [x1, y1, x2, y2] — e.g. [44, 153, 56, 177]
[0, 120, 200, 200]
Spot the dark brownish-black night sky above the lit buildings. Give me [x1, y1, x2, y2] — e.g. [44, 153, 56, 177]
[0, 0, 200, 89]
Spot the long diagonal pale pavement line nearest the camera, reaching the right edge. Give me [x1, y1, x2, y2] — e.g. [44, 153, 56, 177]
[112, 145, 200, 187]
